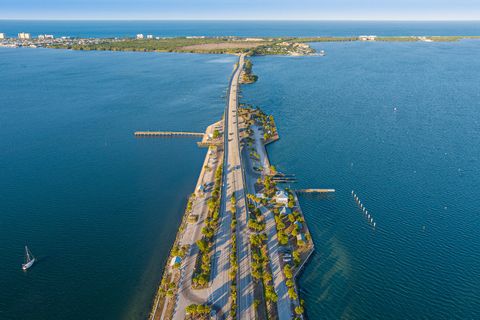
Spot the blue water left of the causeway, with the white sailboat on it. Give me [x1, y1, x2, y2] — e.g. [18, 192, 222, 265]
[0, 49, 235, 320]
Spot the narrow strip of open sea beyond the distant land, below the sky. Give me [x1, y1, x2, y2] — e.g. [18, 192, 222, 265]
[0, 20, 480, 38]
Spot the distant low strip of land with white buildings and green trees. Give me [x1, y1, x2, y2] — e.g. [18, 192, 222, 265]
[0, 32, 480, 56]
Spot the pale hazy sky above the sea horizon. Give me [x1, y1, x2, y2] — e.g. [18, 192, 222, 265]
[0, 0, 480, 20]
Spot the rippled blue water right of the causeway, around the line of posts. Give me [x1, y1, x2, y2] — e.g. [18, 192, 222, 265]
[243, 41, 480, 320]
